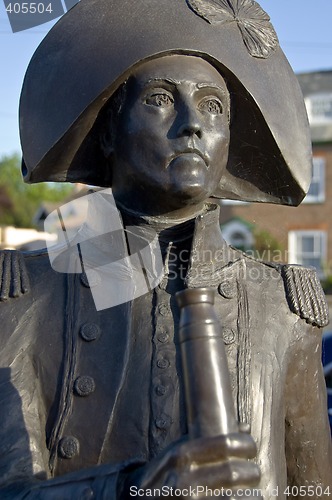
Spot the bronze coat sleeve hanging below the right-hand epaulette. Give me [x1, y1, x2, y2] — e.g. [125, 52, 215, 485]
[286, 319, 332, 498]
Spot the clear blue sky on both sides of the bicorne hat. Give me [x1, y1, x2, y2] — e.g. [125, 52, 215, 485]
[0, 0, 332, 156]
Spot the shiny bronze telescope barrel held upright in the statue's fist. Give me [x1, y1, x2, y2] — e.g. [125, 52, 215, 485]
[177, 288, 239, 438]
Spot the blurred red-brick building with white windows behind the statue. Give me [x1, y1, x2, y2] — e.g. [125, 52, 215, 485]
[221, 70, 332, 278]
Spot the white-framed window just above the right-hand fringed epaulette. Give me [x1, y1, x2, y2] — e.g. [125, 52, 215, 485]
[288, 230, 327, 277]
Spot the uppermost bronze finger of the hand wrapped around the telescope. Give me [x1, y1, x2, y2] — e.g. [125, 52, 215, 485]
[174, 433, 256, 466]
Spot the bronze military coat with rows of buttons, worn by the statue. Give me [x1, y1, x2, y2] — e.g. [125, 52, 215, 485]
[0, 205, 330, 500]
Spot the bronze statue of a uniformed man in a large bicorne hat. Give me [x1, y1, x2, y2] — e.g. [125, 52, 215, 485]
[0, 0, 332, 500]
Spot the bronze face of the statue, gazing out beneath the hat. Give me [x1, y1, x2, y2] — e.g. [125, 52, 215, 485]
[112, 55, 230, 213]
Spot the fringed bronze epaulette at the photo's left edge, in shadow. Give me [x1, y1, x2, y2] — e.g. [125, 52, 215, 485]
[0, 250, 29, 301]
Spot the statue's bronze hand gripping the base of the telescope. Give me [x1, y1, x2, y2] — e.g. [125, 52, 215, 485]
[126, 432, 260, 500]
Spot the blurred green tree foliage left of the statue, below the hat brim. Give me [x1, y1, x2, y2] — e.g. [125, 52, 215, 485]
[0, 154, 73, 228]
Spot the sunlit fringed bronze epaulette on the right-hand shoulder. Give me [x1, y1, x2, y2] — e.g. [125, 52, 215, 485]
[282, 265, 329, 327]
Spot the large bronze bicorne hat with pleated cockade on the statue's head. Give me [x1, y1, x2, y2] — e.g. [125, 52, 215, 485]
[20, 0, 312, 205]
